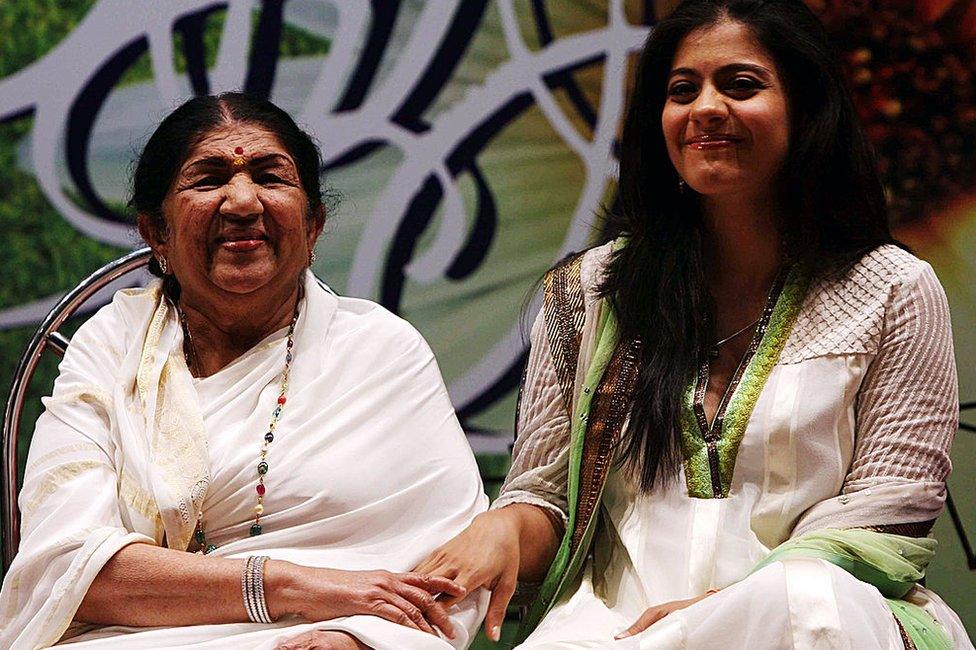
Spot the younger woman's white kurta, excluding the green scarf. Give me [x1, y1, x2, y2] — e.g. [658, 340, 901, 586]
[500, 240, 973, 650]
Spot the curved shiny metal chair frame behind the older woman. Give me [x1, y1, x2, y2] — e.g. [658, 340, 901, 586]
[0, 248, 152, 573]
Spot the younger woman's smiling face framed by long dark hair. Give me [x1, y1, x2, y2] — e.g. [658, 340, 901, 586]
[661, 21, 790, 198]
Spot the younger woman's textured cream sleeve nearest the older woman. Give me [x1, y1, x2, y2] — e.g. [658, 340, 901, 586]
[491, 306, 570, 524]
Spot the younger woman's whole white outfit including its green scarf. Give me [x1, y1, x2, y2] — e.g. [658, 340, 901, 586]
[500, 244, 973, 650]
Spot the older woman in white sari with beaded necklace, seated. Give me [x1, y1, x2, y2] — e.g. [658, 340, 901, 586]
[0, 94, 487, 650]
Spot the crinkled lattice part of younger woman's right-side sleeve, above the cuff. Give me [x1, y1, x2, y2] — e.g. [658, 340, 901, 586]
[843, 263, 959, 505]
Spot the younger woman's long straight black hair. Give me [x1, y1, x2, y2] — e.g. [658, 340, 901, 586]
[600, 0, 894, 492]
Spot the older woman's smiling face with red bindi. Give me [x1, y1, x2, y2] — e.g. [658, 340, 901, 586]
[153, 123, 322, 294]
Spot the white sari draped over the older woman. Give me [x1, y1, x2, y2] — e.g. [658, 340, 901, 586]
[0, 274, 487, 650]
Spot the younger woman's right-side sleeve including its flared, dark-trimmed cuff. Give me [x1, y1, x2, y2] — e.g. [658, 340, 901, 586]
[793, 261, 959, 537]
